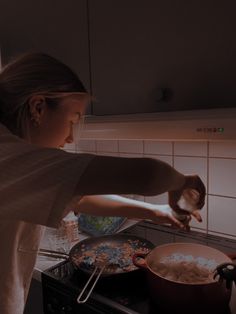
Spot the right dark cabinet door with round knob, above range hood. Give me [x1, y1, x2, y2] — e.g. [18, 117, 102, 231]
[89, 0, 236, 115]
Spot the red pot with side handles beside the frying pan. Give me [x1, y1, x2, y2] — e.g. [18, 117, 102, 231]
[133, 243, 236, 314]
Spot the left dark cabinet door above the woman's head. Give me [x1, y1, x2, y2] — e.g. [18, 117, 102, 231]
[0, 0, 90, 113]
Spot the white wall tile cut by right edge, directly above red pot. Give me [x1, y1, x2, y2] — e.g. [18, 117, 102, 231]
[208, 195, 236, 236]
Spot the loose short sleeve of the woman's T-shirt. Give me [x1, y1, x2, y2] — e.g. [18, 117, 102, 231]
[0, 124, 94, 227]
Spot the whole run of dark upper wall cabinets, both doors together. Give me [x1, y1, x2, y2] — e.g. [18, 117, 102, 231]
[0, 0, 236, 115]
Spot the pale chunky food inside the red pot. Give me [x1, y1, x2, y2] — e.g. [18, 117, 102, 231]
[150, 253, 217, 284]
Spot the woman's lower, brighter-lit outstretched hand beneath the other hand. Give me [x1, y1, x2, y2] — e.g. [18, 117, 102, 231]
[149, 205, 201, 231]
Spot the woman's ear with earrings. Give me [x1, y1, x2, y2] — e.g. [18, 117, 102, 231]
[29, 95, 47, 125]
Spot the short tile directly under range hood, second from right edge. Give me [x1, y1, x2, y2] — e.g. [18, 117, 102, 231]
[174, 141, 207, 157]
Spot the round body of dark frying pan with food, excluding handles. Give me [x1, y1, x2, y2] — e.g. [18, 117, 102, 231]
[69, 234, 154, 276]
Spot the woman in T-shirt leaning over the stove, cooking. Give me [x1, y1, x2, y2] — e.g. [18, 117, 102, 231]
[0, 53, 205, 314]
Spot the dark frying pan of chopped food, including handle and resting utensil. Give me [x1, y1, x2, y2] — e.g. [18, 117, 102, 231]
[39, 234, 155, 303]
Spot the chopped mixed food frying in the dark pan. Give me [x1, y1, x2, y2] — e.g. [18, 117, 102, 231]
[72, 240, 150, 273]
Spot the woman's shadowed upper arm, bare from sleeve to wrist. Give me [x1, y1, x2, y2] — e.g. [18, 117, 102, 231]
[76, 156, 185, 195]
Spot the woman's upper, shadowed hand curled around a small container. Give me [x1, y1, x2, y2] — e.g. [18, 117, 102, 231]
[168, 175, 206, 221]
